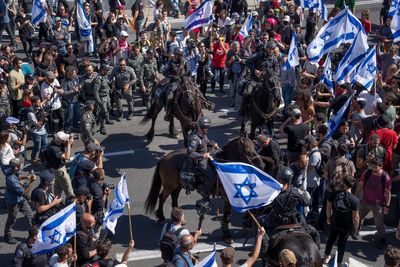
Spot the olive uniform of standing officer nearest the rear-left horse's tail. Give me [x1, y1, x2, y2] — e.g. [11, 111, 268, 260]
[109, 66, 137, 120]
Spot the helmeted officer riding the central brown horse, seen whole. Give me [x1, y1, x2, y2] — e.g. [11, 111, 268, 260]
[187, 117, 218, 207]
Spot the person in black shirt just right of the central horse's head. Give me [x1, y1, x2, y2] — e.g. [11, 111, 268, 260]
[256, 134, 282, 177]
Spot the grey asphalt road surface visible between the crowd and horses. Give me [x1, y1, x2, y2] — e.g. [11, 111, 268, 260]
[0, 1, 399, 266]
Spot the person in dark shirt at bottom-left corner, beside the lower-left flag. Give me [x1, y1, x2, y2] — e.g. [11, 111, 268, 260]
[11, 225, 47, 267]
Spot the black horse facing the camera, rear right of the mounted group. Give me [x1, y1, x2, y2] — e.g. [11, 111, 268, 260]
[241, 77, 280, 139]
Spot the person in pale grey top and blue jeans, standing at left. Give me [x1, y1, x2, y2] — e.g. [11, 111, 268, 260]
[28, 96, 47, 164]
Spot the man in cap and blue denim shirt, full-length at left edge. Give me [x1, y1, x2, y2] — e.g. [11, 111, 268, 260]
[4, 158, 36, 244]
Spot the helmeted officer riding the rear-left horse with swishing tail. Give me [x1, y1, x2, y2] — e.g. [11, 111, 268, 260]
[162, 47, 190, 121]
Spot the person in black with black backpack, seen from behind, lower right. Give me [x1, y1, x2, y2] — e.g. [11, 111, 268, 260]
[324, 175, 360, 266]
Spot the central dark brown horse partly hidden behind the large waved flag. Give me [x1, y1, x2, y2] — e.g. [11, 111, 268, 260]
[145, 135, 264, 243]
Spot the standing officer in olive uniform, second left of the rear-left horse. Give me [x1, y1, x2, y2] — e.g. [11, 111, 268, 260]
[93, 64, 114, 135]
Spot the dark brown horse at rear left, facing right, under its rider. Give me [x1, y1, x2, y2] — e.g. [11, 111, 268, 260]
[140, 76, 214, 147]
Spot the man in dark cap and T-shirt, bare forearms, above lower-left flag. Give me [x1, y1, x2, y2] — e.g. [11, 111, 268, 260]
[31, 170, 62, 225]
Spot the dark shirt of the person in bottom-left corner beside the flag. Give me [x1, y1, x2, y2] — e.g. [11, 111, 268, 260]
[11, 240, 48, 267]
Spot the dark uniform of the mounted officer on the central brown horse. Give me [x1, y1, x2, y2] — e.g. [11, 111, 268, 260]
[187, 131, 215, 193]
